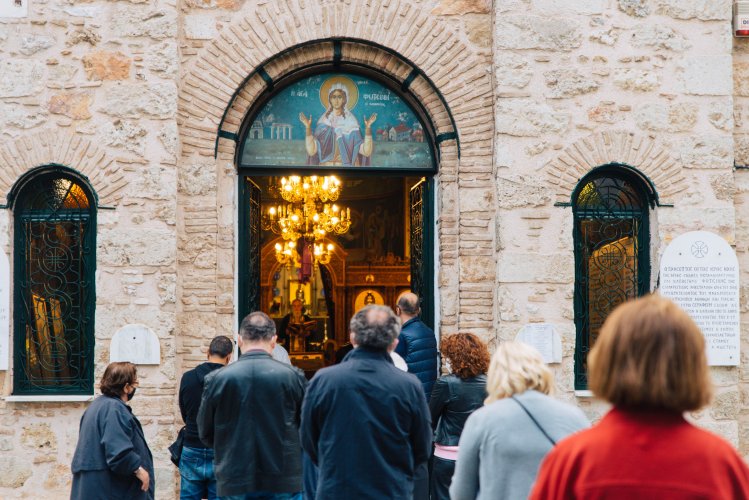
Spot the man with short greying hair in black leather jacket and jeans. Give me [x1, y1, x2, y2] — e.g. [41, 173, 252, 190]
[198, 312, 307, 500]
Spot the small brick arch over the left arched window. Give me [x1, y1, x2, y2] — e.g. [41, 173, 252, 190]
[0, 130, 127, 206]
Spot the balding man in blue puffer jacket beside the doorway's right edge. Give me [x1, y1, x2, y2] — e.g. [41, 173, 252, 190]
[395, 292, 437, 401]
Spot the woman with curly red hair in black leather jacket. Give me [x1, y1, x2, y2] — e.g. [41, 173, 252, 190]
[429, 333, 489, 500]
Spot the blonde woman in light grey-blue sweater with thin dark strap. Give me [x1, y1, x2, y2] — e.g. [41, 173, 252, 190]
[450, 342, 588, 500]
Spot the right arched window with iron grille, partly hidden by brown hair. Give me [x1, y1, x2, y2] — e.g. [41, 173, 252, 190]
[572, 167, 653, 390]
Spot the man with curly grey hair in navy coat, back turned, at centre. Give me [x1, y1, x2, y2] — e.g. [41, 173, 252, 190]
[301, 305, 432, 500]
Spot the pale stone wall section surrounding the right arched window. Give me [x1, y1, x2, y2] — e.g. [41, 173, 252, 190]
[493, 0, 749, 453]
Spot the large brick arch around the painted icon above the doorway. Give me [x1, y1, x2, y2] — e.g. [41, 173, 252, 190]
[178, 0, 493, 161]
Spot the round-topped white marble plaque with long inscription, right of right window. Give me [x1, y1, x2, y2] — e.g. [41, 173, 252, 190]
[660, 231, 741, 366]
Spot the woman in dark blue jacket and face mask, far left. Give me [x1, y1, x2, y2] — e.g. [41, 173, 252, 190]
[70, 362, 154, 500]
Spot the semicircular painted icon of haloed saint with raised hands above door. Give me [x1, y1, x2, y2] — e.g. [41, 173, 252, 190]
[241, 73, 434, 170]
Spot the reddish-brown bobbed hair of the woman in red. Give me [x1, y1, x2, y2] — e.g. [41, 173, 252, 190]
[588, 295, 712, 413]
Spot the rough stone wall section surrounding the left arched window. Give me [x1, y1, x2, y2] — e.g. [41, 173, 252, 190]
[0, 0, 180, 498]
